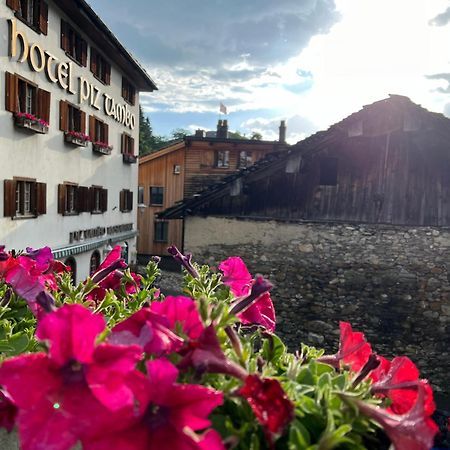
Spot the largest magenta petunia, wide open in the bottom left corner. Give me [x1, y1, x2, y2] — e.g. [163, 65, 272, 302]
[0, 305, 141, 450]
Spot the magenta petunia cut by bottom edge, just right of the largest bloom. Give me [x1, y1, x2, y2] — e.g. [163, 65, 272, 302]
[83, 359, 225, 450]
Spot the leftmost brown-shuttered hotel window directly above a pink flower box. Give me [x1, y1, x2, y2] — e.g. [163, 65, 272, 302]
[5, 72, 50, 124]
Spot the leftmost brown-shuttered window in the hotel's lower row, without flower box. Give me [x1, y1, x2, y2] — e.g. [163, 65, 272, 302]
[3, 178, 47, 218]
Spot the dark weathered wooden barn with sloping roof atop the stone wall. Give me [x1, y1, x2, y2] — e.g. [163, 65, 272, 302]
[160, 95, 450, 226]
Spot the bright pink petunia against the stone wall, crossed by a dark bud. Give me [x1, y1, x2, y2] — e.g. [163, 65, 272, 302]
[219, 256, 275, 332]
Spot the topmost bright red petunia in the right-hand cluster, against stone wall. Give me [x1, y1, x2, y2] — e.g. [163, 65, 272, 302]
[318, 322, 372, 372]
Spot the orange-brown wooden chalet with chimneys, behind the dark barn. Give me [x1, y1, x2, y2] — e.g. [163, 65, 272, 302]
[137, 120, 288, 257]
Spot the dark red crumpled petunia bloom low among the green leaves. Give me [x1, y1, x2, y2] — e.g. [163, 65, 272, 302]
[239, 375, 294, 434]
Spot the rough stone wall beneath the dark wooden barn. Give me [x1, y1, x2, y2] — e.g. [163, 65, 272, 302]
[185, 217, 450, 393]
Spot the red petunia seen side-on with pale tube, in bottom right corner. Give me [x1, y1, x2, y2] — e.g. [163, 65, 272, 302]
[356, 384, 438, 450]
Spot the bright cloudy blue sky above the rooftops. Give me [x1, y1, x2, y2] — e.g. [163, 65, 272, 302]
[88, 0, 450, 143]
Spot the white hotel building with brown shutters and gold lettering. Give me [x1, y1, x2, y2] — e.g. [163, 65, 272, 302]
[0, 0, 156, 281]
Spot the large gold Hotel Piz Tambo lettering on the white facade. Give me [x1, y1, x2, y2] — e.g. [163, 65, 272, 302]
[8, 19, 136, 130]
